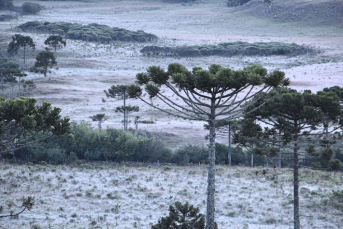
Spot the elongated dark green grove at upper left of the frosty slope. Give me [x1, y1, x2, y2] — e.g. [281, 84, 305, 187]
[18, 21, 157, 43]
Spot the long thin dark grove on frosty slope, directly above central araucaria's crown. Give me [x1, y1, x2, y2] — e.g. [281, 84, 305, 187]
[141, 42, 316, 57]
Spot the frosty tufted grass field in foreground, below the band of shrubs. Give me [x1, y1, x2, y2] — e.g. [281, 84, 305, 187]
[0, 164, 343, 229]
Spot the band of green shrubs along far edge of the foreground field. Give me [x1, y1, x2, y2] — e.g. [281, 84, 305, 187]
[3, 122, 343, 168]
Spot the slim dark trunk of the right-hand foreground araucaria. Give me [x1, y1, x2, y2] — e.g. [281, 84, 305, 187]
[293, 121, 300, 229]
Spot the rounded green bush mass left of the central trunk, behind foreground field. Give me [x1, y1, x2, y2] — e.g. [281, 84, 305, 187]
[8, 122, 171, 164]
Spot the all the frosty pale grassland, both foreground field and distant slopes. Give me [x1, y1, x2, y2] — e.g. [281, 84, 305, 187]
[0, 0, 343, 229]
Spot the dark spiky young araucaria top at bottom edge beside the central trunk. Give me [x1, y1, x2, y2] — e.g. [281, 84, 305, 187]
[151, 202, 205, 229]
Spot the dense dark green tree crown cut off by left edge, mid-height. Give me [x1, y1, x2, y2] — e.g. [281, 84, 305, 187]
[0, 97, 70, 154]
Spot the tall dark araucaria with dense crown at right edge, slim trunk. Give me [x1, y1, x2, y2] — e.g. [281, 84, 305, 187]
[246, 88, 341, 229]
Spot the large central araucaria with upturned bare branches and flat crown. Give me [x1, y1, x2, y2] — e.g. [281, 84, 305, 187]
[127, 63, 289, 229]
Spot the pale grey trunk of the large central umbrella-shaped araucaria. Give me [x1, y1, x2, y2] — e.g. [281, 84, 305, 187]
[206, 104, 216, 229]
